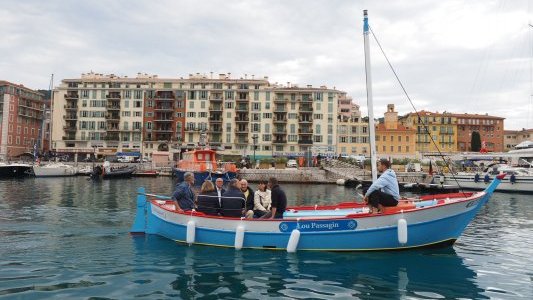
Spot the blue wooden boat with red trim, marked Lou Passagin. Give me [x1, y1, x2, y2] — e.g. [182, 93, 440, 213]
[131, 175, 505, 252]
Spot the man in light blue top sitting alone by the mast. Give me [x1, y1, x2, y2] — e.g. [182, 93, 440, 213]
[363, 158, 400, 213]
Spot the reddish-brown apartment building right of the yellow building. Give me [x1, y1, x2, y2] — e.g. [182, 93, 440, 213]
[452, 113, 505, 152]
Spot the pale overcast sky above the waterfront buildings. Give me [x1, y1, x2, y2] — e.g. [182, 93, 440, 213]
[0, 0, 533, 129]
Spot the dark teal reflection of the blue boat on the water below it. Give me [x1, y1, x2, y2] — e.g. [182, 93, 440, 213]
[133, 236, 485, 299]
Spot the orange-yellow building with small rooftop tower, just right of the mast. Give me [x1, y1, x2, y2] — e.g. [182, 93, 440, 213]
[376, 104, 416, 158]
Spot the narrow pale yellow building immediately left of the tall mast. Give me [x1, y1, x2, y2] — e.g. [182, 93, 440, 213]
[337, 102, 370, 156]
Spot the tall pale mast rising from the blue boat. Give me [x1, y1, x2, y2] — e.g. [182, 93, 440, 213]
[363, 9, 378, 182]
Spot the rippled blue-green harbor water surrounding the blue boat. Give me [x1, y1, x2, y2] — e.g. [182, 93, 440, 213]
[0, 177, 533, 299]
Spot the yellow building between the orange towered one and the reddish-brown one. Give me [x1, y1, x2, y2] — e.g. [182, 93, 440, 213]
[400, 110, 457, 153]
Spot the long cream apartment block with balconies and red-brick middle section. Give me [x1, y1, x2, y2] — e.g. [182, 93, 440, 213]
[52, 73, 345, 157]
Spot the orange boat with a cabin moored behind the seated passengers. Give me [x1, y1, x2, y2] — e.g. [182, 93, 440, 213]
[173, 149, 237, 185]
